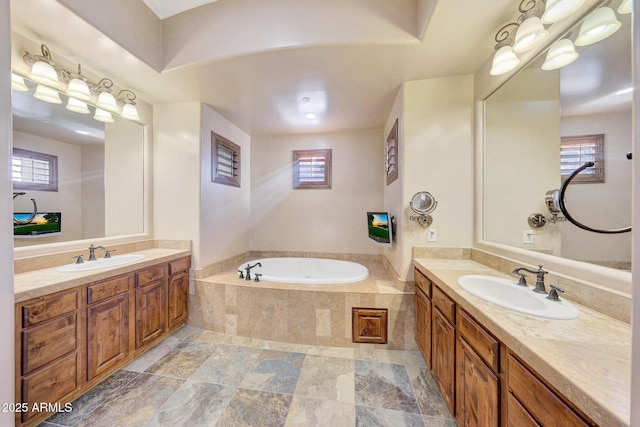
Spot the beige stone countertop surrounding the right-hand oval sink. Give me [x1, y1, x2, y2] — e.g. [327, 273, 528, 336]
[413, 258, 631, 426]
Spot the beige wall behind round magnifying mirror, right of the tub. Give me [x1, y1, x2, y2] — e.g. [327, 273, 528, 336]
[385, 75, 473, 279]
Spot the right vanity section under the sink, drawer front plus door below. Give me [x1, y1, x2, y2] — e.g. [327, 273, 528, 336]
[456, 307, 502, 427]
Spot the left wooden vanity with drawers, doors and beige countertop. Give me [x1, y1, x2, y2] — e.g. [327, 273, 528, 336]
[15, 248, 190, 426]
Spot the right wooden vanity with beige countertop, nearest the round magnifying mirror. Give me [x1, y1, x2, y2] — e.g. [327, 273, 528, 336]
[414, 259, 631, 427]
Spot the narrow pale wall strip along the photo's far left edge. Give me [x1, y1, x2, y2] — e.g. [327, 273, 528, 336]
[0, 0, 16, 420]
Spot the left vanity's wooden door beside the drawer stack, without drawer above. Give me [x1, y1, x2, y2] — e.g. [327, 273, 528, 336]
[87, 293, 129, 380]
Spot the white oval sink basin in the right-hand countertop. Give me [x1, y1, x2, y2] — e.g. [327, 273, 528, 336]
[458, 275, 580, 320]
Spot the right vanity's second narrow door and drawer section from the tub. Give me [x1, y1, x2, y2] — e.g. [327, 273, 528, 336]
[431, 286, 456, 415]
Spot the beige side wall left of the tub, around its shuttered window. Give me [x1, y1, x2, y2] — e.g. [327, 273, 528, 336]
[198, 105, 252, 266]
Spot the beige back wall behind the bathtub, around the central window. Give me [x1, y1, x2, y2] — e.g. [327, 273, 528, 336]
[251, 129, 384, 254]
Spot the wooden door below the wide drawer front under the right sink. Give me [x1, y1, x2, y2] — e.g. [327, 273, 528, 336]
[456, 337, 500, 427]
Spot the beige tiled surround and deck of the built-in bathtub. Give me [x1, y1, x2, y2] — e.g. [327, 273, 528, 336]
[189, 254, 417, 350]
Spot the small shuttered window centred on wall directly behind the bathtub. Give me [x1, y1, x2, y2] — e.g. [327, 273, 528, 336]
[293, 149, 331, 189]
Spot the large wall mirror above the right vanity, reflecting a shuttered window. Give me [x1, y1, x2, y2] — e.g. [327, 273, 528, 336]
[482, 1, 633, 270]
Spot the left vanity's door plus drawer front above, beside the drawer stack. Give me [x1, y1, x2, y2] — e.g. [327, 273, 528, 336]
[87, 274, 134, 380]
